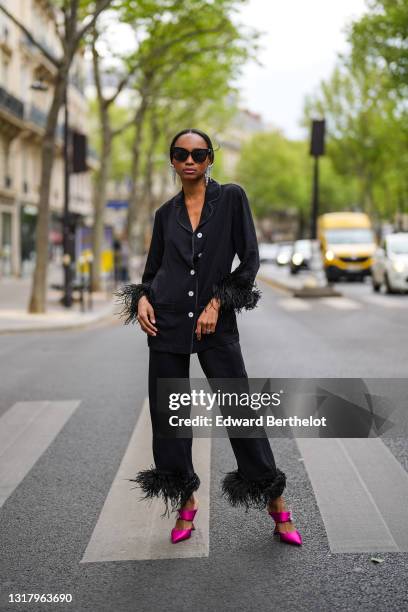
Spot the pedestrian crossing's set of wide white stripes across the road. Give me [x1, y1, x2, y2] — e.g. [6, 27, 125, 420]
[0, 398, 408, 564]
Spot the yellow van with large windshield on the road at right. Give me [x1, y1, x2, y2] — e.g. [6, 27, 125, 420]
[317, 212, 377, 281]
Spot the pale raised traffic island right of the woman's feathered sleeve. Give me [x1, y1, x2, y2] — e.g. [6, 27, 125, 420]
[257, 263, 342, 298]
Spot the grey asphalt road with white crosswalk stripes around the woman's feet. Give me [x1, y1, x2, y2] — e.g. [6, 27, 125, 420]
[0, 274, 408, 612]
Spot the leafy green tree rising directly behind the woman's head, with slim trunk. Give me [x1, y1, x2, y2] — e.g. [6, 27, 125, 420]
[119, 0, 257, 255]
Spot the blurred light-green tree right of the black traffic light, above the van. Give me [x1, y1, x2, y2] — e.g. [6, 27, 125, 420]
[302, 57, 406, 220]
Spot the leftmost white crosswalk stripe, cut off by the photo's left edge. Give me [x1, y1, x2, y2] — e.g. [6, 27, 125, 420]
[0, 400, 80, 507]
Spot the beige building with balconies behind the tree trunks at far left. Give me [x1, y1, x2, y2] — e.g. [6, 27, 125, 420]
[0, 0, 92, 278]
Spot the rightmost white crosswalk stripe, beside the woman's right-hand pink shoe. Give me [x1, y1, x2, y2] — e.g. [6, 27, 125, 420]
[296, 438, 408, 553]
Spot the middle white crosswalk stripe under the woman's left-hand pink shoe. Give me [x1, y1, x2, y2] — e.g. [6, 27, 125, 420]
[81, 398, 211, 563]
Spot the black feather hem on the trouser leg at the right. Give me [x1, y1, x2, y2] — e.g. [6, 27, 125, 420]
[222, 468, 286, 512]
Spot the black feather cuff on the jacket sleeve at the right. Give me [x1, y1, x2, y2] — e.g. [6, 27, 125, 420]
[212, 272, 262, 312]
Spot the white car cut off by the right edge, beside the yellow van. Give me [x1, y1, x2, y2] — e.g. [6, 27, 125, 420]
[371, 232, 408, 293]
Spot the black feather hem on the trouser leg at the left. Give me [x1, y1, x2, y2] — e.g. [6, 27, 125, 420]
[128, 465, 200, 517]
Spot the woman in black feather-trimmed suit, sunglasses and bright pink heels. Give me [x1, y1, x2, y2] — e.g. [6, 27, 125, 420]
[115, 129, 301, 545]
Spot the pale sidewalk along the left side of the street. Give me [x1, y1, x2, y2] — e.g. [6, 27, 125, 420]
[0, 266, 117, 334]
